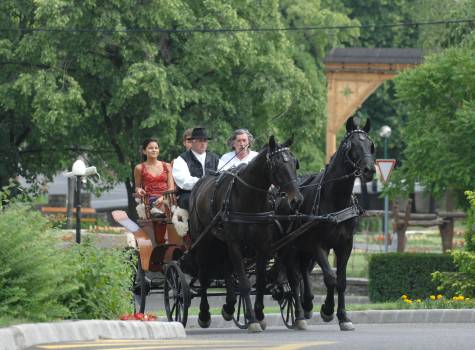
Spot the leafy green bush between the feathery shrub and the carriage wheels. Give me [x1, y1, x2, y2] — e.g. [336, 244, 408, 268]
[63, 239, 135, 319]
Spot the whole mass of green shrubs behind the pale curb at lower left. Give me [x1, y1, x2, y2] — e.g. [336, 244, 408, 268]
[0, 204, 133, 321]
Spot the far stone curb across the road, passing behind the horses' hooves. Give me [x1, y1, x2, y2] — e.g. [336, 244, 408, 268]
[178, 309, 475, 329]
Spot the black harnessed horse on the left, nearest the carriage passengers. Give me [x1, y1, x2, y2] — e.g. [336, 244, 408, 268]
[189, 136, 303, 332]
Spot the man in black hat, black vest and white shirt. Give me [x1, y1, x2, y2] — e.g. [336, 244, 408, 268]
[172, 128, 219, 210]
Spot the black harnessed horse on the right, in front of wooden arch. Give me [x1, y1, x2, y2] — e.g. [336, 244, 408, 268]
[279, 118, 375, 330]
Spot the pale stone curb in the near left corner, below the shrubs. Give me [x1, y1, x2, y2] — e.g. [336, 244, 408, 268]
[0, 320, 186, 350]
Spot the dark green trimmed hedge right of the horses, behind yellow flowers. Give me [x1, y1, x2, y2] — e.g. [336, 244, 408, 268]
[368, 253, 455, 302]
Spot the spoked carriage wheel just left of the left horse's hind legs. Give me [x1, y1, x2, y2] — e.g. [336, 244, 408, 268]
[163, 261, 191, 327]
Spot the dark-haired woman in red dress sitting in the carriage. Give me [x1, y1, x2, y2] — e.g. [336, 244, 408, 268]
[134, 139, 175, 226]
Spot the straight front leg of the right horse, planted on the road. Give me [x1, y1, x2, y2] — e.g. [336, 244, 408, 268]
[335, 242, 355, 331]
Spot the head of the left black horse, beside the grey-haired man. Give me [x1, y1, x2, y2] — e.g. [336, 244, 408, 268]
[266, 136, 303, 210]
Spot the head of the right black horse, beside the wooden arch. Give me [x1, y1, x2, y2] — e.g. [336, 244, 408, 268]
[340, 117, 376, 182]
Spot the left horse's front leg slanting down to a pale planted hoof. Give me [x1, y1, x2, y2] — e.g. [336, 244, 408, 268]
[227, 240, 262, 332]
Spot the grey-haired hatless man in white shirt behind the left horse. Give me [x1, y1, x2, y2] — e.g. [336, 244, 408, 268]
[218, 129, 258, 171]
